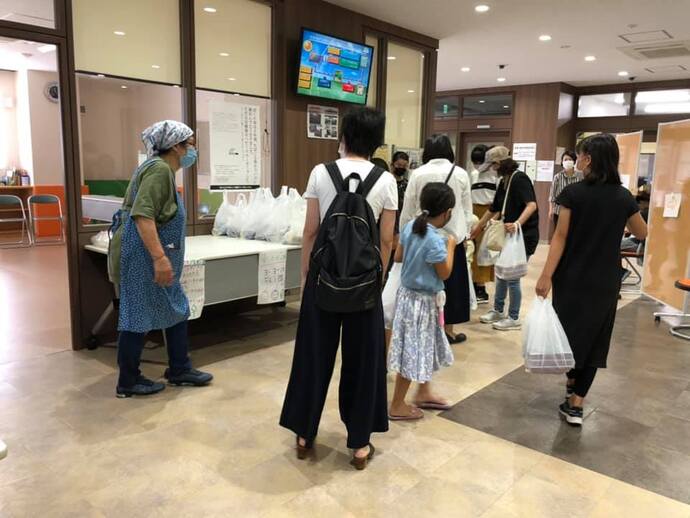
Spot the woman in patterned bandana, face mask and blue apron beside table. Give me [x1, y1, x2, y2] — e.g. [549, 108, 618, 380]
[108, 121, 213, 398]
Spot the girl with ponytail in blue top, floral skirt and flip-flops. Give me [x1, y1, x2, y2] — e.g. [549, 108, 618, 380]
[388, 182, 454, 421]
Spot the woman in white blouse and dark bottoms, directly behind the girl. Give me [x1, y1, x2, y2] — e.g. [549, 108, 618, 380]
[400, 135, 472, 343]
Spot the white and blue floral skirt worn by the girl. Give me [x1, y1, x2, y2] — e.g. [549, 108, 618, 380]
[388, 286, 453, 383]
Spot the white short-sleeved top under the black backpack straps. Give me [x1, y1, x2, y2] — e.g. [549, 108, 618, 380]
[304, 158, 398, 221]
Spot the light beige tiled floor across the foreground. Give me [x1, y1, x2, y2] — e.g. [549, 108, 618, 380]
[0, 247, 690, 518]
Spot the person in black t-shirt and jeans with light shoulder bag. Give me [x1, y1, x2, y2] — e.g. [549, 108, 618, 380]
[472, 158, 539, 331]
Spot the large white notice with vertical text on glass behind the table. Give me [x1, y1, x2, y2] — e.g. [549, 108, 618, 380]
[208, 101, 262, 190]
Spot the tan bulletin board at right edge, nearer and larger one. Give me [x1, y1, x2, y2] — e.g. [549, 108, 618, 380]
[642, 119, 690, 309]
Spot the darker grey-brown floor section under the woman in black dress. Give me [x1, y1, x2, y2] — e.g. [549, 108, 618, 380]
[443, 299, 690, 503]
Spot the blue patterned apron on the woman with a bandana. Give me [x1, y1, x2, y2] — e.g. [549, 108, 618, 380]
[111, 158, 189, 333]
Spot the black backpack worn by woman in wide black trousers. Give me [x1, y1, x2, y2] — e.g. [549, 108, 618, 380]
[309, 162, 384, 313]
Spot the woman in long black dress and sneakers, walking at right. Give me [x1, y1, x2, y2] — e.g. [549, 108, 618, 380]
[536, 135, 647, 426]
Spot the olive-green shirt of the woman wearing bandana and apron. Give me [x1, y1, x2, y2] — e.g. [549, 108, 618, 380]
[108, 159, 177, 287]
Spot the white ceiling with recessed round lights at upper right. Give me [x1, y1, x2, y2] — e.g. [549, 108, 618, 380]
[329, 0, 690, 91]
